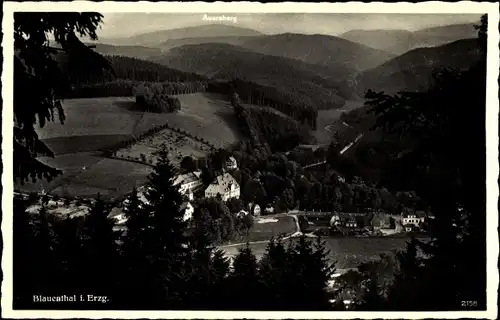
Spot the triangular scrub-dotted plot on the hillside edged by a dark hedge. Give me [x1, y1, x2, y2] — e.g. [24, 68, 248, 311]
[116, 129, 211, 165]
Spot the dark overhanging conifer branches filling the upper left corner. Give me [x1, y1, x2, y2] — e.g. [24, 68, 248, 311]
[14, 12, 114, 182]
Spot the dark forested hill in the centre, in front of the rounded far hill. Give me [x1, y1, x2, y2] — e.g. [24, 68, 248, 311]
[156, 43, 352, 109]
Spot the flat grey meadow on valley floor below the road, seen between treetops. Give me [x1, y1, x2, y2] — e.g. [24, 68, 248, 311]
[223, 237, 426, 269]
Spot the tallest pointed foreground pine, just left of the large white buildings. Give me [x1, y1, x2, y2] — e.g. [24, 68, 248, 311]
[123, 149, 189, 309]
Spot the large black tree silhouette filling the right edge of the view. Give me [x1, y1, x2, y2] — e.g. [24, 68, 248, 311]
[366, 16, 487, 310]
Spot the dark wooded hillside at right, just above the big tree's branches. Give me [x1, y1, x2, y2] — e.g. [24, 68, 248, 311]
[356, 39, 480, 95]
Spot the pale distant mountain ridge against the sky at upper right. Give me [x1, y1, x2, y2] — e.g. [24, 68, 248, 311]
[339, 23, 477, 54]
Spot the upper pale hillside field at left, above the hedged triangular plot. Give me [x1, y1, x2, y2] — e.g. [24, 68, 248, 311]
[37, 93, 241, 154]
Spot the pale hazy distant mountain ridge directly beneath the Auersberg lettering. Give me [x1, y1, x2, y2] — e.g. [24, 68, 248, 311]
[103, 24, 263, 47]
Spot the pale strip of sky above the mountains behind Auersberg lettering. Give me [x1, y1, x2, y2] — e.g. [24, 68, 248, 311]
[98, 13, 480, 38]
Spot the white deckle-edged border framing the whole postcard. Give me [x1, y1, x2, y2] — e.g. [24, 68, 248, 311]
[1, 1, 500, 319]
